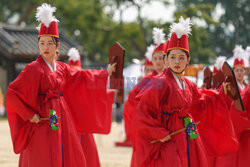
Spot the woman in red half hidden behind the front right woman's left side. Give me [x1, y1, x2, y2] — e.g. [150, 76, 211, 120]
[123, 27, 167, 147]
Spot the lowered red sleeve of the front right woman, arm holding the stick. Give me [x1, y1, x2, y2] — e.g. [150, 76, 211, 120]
[134, 81, 169, 166]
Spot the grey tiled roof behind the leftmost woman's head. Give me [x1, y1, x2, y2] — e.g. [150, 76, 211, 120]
[0, 24, 82, 61]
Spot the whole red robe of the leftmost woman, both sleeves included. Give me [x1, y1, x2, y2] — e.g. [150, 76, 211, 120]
[6, 56, 111, 167]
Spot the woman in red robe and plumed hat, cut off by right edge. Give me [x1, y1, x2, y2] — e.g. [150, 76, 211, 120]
[211, 45, 250, 167]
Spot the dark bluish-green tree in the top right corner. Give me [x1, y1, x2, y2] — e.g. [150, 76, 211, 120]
[177, 0, 250, 57]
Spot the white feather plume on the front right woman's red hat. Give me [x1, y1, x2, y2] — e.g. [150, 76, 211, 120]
[169, 16, 192, 39]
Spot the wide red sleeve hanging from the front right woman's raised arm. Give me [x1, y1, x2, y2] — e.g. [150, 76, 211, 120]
[189, 85, 238, 156]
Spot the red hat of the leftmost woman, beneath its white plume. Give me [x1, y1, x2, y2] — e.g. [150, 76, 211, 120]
[38, 21, 59, 38]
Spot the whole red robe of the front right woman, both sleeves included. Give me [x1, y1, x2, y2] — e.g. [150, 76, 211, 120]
[133, 69, 238, 167]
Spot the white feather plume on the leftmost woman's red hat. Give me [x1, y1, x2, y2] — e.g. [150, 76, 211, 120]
[36, 3, 58, 27]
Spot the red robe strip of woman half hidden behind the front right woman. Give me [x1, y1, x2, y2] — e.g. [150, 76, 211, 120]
[123, 70, 158, 143]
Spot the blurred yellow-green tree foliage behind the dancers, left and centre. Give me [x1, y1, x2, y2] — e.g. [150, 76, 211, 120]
[0, 0, 221, 63]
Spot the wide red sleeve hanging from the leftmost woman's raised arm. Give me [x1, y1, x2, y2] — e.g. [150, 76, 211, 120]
[64, 65, 112, 134]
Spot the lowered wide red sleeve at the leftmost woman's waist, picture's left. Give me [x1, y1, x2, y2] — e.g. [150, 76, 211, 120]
[6, 64, 42, 153]
